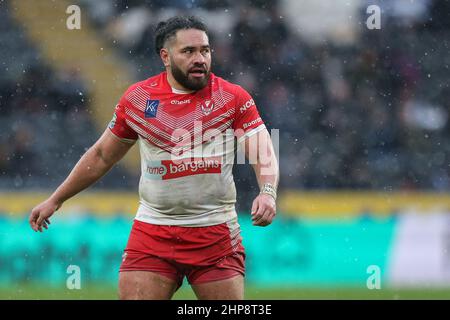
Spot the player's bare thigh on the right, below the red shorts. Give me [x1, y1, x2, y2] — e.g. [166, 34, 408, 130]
[191, 275, 244, 300]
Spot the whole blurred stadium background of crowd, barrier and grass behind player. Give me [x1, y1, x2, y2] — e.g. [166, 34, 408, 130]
[0, 0, 450, 299]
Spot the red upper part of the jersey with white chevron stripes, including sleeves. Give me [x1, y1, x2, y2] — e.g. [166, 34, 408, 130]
[111, 72, 262, 152]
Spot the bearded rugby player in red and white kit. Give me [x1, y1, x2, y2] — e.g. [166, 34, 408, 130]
[29, 16, 279, 299]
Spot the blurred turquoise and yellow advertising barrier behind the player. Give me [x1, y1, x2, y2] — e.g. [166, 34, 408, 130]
[0, 193, 450, 288]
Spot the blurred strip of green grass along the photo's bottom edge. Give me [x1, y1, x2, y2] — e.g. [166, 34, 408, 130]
[0, 284, 450, 300]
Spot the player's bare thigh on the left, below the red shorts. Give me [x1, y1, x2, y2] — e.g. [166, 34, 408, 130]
[119, 271, 178, 300]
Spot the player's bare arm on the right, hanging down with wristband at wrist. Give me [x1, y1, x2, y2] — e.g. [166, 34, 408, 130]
[243, 129, 279, 226]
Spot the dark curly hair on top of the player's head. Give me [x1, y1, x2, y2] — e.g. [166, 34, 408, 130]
[155, 16, 208, 55]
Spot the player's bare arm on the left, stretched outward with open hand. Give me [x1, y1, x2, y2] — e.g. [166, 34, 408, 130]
[29, 129, 133, 232]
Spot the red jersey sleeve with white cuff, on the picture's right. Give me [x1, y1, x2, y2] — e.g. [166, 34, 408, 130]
[233, 86, 266, 142]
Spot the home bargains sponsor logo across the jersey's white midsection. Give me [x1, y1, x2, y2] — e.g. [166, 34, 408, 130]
[145, 157, 222, 180]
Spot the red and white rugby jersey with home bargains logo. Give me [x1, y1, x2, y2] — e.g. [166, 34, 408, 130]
[109, 72, 265, 226]
